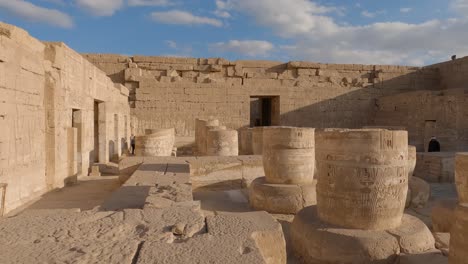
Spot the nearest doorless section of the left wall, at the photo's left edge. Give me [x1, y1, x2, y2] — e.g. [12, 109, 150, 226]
[0, 23, 47, 213]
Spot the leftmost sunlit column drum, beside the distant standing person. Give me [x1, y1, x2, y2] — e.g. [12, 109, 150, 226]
[135, 128, 175, 157]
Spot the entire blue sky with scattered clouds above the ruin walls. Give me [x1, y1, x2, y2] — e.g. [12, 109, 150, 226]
[0, 0, 468, 65]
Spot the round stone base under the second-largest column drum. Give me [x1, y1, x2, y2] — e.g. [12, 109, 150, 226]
[249, 177, 317, 214]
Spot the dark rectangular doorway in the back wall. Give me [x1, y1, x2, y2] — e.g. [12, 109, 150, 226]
[250, 96, 280, 127]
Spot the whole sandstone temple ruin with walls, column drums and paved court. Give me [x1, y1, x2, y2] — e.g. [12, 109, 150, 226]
[0, 23, 468, 264]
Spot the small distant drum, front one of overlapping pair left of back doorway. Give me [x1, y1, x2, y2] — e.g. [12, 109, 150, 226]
[206, 129, 239, 156]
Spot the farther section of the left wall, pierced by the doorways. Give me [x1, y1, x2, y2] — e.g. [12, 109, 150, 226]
[45, 43, 130, 187]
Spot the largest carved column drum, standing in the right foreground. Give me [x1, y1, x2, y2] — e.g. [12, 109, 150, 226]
[316, 129, 408, 230]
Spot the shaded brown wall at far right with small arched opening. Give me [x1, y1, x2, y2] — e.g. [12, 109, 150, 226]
[374, 89, 468, 151]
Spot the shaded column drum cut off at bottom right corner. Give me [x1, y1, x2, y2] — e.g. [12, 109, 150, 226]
[449, 204, 468, 264]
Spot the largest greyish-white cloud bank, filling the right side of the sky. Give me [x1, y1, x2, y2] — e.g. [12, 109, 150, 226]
[218, 0, 468, 64]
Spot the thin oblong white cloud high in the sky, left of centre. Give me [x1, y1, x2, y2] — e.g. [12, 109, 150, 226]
[151, 10, 223, 27]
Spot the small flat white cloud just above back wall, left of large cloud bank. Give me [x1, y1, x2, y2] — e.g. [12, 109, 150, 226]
[211, 40, 275, 57]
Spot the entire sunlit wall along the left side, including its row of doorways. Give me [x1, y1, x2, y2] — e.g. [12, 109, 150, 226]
[0, 23, 130, 212]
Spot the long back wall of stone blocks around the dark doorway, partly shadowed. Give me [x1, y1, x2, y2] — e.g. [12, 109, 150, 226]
[84, 54, 439, 136]
